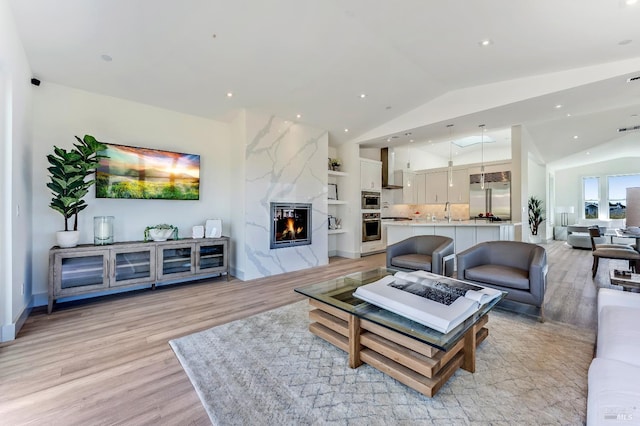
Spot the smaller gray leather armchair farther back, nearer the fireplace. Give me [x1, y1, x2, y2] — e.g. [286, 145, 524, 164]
[387, 235, 454, 276]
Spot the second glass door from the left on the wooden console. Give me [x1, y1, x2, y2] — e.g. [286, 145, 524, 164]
[110, 246, 156, 287]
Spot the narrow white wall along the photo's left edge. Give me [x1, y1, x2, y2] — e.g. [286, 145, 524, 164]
[0, 0, 32, 341]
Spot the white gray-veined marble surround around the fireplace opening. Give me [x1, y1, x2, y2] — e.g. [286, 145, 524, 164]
[235, 113, 329, 280]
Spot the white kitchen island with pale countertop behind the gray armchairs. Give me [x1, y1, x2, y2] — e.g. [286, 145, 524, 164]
[383, 219, 521, 253]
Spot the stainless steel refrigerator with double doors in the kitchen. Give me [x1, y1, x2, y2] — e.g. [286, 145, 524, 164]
[469, 171, 511, 220]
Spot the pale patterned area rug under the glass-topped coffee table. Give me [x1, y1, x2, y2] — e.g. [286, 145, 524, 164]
[170, 301, 594, 425]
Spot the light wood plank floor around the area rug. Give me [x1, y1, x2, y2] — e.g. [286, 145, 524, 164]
[0, 242, 618, 425]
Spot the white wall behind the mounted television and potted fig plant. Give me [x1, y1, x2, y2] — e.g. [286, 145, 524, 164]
[28, 81, 234, 305]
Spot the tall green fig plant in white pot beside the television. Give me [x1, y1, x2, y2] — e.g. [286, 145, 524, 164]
[47, 135, 107, 247]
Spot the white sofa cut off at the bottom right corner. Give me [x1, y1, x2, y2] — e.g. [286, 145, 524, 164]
[587, 288, 640, 426]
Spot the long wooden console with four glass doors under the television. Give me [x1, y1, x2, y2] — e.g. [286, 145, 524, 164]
[47, 237, 229, 313]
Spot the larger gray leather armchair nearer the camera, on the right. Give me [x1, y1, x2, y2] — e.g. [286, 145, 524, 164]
[457, 241, 548, 319]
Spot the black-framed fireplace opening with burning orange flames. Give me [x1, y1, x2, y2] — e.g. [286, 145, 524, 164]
[271, 203, 311, 249]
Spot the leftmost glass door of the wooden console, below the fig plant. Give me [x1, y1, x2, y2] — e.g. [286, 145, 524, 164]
[53, 250, 109, 296]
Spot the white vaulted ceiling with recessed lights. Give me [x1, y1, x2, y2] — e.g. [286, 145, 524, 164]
[10, 0, 640, 169]
